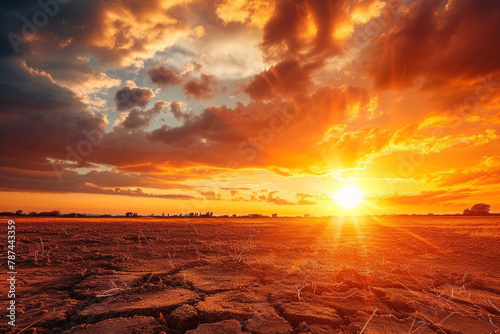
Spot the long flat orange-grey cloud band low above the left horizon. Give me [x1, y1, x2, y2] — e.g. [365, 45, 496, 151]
[0, 157, 213, 199]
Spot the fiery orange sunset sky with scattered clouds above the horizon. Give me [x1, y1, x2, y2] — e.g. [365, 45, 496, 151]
[0, 0, 500, 215]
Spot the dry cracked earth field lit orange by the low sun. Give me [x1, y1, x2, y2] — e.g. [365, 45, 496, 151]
[0, 217, 500, 334]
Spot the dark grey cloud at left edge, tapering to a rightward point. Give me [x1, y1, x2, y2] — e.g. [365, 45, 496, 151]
[0, 59, 105, 169]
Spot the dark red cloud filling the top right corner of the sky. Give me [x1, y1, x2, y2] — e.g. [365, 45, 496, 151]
[369, 0, 500, 88]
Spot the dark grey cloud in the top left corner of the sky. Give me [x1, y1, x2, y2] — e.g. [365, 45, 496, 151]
[0, 0, 116, 90]
